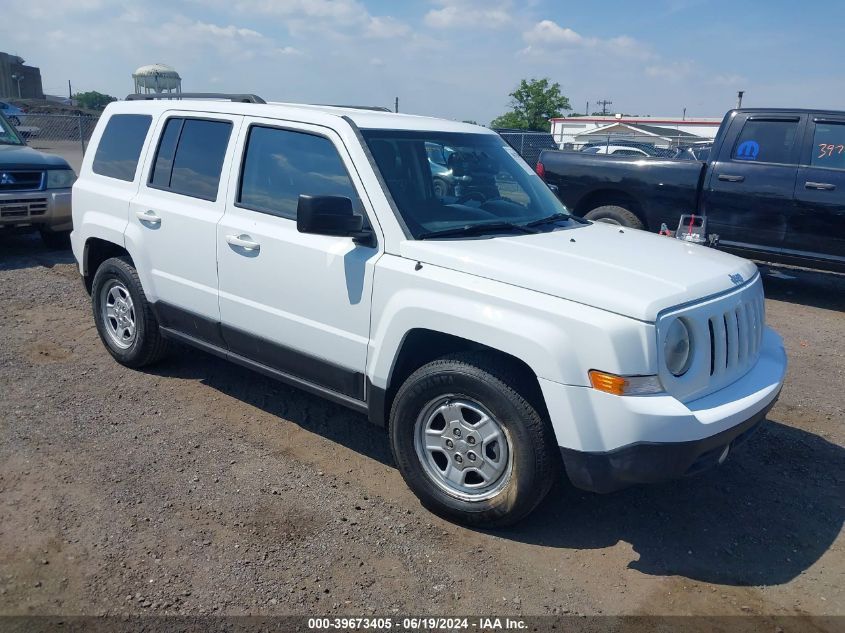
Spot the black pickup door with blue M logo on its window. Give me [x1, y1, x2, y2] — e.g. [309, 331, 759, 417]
[702, 114, 806, 250]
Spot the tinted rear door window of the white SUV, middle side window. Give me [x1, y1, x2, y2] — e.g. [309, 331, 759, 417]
[149, 118, 232, 201]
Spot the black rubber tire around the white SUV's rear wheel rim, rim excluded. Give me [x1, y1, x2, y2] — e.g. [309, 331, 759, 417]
[91, 257, 168, 368]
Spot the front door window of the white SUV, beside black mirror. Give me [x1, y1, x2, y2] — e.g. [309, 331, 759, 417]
[237, 125, 361, 220]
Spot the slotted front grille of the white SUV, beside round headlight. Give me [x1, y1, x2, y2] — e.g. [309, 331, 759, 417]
[708, 295, 764, 376]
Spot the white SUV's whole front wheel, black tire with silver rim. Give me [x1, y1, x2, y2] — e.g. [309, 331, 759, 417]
[390, 353, 560, 527]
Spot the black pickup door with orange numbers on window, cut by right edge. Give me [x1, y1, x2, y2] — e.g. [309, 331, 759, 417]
[784, 116, 845, 262]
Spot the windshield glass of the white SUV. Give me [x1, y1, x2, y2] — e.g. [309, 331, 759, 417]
[362, 130, 567, 239]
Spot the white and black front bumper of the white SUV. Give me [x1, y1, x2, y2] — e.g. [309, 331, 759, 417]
[540, 329, 786, 492]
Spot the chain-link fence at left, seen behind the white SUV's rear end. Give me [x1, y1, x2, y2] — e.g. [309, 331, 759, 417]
[9, 114, 99, 173]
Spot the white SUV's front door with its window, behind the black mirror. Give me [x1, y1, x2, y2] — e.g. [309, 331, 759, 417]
[217, 119, 379, 400]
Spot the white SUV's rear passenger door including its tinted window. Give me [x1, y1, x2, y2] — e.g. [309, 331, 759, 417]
[126, 111, 242, 346]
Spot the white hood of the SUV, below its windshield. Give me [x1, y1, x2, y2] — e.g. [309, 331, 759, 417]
[400, 223, 757, 322]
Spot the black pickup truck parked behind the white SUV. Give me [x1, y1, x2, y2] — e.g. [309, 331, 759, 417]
[537, 109, 845, 271]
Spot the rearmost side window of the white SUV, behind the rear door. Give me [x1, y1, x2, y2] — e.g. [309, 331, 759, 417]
[91, 114, 153, 182]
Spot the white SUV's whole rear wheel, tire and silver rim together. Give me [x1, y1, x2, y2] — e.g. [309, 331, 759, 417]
[91, 257, 167, 367]
